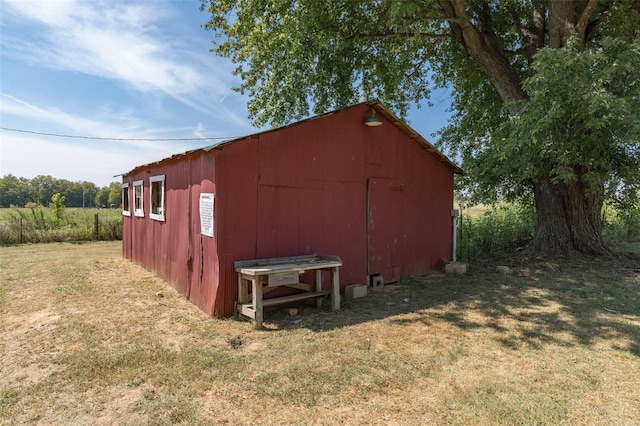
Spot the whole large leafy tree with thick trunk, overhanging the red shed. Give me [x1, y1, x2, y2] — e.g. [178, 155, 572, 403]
[202, 0, 640, 254]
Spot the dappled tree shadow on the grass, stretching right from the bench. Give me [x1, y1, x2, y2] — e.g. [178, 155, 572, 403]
[266, 255, 640, 357]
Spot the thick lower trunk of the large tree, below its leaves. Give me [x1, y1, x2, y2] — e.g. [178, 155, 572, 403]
[529, 174, 610, 255]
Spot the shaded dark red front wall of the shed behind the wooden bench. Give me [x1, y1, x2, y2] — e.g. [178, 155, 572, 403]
[218, 103, 453, 314]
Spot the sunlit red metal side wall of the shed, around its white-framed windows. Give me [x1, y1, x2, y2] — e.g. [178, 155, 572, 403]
[123, 154, 218, 314]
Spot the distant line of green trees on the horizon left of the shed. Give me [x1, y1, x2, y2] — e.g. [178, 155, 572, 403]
[0, 174, 122, 207]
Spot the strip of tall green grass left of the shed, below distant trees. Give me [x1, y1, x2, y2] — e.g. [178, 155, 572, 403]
[0, 206, 122, 245]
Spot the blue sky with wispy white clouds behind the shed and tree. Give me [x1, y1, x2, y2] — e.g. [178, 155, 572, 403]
[0, 0, 449, 186]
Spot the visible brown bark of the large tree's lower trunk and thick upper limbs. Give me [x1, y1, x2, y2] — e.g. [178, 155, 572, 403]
[438, 0, 610, 255]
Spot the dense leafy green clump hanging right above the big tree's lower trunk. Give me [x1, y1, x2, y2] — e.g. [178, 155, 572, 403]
[476, 38, 640, 198]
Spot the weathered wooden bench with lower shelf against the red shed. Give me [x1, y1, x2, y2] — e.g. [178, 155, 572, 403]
[234, 254, 342, 329]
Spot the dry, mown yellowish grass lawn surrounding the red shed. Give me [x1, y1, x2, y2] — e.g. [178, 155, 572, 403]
[0, 242, 640, 426]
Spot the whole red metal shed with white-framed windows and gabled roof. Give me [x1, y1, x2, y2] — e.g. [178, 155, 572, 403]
[122, 101, 461, 316]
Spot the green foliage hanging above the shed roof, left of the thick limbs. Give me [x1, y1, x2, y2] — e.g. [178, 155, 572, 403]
[203, 0, 442, 126]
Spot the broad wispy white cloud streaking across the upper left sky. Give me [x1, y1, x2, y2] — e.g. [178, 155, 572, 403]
[2, 0, 246, 124]
